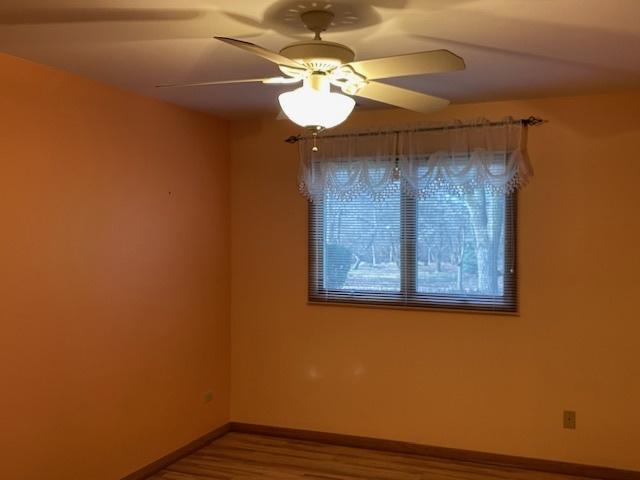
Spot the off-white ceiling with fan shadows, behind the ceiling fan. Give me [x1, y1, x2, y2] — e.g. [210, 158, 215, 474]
[0, 0, 640, 116]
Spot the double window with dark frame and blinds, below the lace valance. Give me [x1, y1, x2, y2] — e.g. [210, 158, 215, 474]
[309, 163, 517, 312]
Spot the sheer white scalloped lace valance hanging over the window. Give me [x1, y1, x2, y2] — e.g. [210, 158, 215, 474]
[299, 118, 533, 201]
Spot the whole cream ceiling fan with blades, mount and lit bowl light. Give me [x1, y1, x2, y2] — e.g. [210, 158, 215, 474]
[159, 10, 465, 132]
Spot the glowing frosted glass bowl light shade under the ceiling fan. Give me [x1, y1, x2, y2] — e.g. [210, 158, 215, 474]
[278, 86, 356, 128]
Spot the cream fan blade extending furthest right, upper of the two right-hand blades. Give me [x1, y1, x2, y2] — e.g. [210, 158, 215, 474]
[347, 50, 465, 80]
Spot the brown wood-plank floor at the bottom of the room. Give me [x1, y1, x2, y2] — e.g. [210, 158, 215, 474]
[149, 432, 596, 480]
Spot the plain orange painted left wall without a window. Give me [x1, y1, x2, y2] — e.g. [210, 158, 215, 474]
[0, 55, 229, 480]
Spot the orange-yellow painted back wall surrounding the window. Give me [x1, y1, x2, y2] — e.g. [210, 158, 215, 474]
[231, 93, 640, 470]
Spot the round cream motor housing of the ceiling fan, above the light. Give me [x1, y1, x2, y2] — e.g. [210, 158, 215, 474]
[280, 40, 356, 73]
